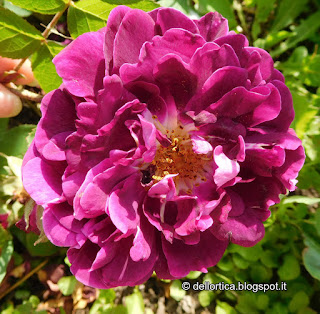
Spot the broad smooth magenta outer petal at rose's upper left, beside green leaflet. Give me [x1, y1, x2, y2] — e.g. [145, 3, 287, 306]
[53, 31, 105, 97]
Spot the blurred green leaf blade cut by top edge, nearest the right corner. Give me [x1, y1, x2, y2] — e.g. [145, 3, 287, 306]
[270, 0, 308, 32]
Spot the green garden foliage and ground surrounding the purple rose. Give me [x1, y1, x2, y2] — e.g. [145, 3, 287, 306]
[0, 0, 320, 314]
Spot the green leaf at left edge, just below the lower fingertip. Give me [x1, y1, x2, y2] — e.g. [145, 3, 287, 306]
[0, 124, 36, 158]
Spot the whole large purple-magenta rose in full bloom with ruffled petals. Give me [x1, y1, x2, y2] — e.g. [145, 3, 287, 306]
[23, 6, 305, 288]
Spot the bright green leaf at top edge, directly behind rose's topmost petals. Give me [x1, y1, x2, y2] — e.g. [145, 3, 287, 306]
[68, 0, 159, 38]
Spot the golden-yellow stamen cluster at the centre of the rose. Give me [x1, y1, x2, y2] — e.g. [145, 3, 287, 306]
[151, 119, 212, 194]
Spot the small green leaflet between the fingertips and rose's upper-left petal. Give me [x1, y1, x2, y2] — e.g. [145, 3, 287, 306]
[31, 42, 63, 93]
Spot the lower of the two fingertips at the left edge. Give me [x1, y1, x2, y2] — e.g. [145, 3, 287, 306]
[0, 84, 22, 118]
